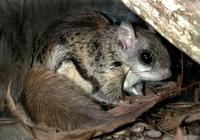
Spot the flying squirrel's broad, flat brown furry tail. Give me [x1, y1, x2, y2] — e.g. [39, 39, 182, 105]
[22, 69, 114, 130]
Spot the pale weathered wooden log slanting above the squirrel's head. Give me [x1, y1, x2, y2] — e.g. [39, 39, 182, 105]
[122, 0, 200, 64]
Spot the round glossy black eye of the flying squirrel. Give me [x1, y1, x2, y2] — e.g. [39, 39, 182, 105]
[140, 50, 153, 65]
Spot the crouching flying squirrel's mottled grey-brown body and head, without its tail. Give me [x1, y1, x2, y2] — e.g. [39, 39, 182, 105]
[33, 12, 171, 104]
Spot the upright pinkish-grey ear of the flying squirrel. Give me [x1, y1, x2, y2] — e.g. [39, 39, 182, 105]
[118, 22, 137, 49]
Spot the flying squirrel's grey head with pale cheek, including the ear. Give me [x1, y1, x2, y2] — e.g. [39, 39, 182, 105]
[118, 22, 171, 81]
